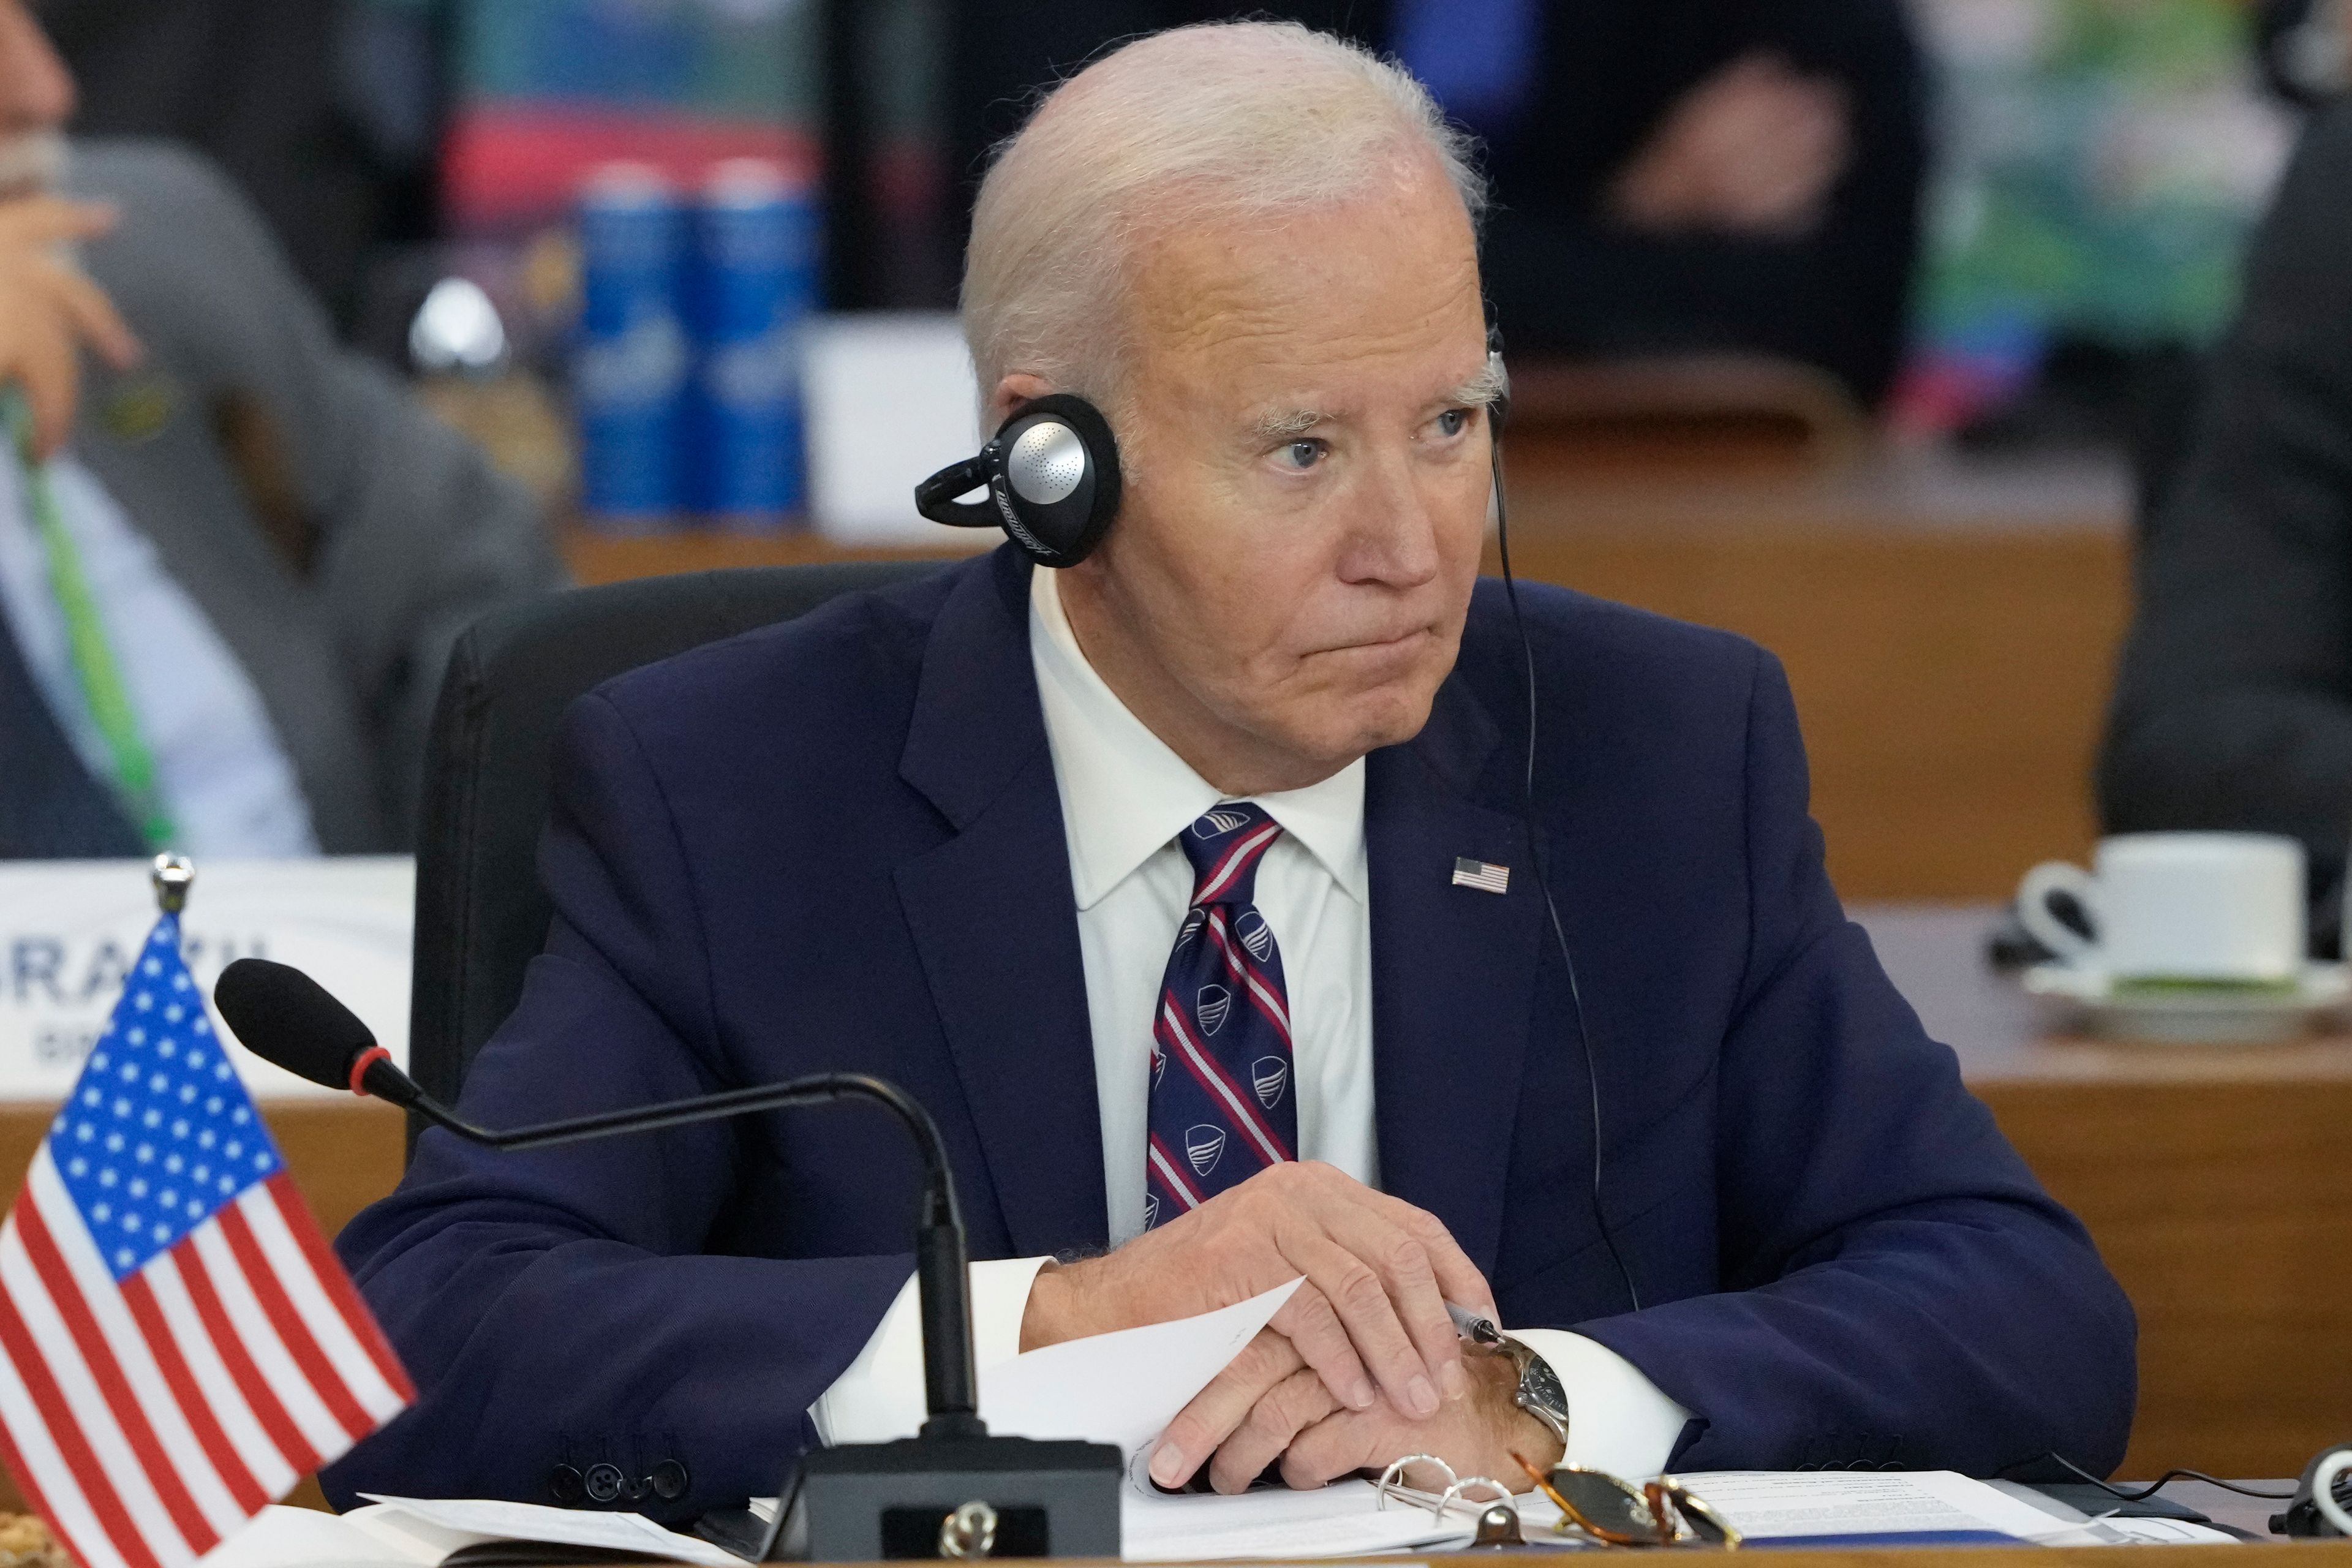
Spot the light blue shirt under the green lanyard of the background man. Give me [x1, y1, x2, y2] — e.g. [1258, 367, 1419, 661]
[0, 456, 317, 861]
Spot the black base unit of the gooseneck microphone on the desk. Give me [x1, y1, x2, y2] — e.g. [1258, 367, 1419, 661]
[696, 1436, 1126, 1563]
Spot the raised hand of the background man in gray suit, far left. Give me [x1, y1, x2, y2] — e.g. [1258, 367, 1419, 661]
[0, 195, 141, 458]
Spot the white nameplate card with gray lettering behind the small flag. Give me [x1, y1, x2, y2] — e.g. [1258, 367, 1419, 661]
[0, 856, 417, 1102]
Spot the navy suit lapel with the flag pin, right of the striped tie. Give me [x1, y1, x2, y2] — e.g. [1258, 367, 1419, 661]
[1364, 677, 1543, 1274]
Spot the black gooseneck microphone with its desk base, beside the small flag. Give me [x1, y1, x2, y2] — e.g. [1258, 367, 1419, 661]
[212, 959, 1122, 1561]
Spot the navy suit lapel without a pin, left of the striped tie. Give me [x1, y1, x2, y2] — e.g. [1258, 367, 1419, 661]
[896, 545, 1110, 1256]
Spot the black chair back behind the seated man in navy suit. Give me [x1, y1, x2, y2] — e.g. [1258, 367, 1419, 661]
[409, 562, 938, 1150]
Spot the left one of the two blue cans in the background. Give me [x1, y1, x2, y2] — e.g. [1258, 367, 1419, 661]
[571, 165, 692, 531]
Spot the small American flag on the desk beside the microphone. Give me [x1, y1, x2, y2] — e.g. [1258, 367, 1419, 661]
[0, 914, 414, 1568]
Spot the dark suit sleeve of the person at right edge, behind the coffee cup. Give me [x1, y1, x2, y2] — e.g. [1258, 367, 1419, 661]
[2098, 108, 2352, 865]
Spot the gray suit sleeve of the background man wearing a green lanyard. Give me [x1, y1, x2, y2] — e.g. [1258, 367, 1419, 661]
[88, 153, 565, 844]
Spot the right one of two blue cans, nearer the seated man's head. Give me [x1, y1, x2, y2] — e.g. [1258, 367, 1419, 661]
[687, 157, 816, 529]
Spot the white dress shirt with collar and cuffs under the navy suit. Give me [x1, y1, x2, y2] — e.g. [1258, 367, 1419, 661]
[809, 569, 1689, 1476]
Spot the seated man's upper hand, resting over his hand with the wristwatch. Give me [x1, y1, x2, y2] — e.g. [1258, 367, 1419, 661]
[1021, 1161, 1493, 1483]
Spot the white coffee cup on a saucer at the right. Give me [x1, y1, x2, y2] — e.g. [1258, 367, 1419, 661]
[2018, 832, 2305, 980]
